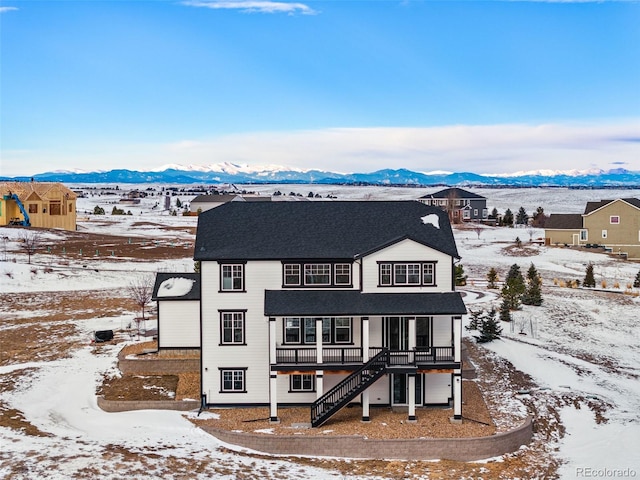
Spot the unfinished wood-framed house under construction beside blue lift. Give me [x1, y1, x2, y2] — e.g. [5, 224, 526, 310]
[0, 182, 77, 230]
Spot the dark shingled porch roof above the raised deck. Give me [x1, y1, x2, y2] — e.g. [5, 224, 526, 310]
[264, 290, 467, 317]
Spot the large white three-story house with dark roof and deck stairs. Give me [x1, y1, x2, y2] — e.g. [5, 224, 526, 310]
[195, 201, 466, 426]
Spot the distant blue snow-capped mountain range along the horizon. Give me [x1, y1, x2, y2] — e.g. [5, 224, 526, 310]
[5, 163, 640, 188]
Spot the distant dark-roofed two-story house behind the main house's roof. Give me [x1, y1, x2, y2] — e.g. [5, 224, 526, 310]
[418, 187, 489, 223]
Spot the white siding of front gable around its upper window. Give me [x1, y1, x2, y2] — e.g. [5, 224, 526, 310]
[362, 240, 452, 293]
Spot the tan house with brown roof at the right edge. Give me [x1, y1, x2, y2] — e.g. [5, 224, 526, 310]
[544, 198, 640, 259]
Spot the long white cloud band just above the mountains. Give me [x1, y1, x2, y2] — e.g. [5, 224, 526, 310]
[2, 119, 640, 176]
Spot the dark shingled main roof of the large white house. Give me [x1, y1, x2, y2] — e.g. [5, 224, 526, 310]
[194, 201, 458, 260]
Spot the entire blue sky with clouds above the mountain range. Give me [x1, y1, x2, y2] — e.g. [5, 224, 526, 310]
[0, 0, 640, 176]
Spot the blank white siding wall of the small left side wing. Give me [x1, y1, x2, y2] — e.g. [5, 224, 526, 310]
[158, 300, 200, 348]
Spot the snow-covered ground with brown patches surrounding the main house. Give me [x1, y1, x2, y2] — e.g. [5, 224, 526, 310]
[0, 185, 640, 479]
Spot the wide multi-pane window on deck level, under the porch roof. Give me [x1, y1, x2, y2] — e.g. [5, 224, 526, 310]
[284, 317, 352, 345]
